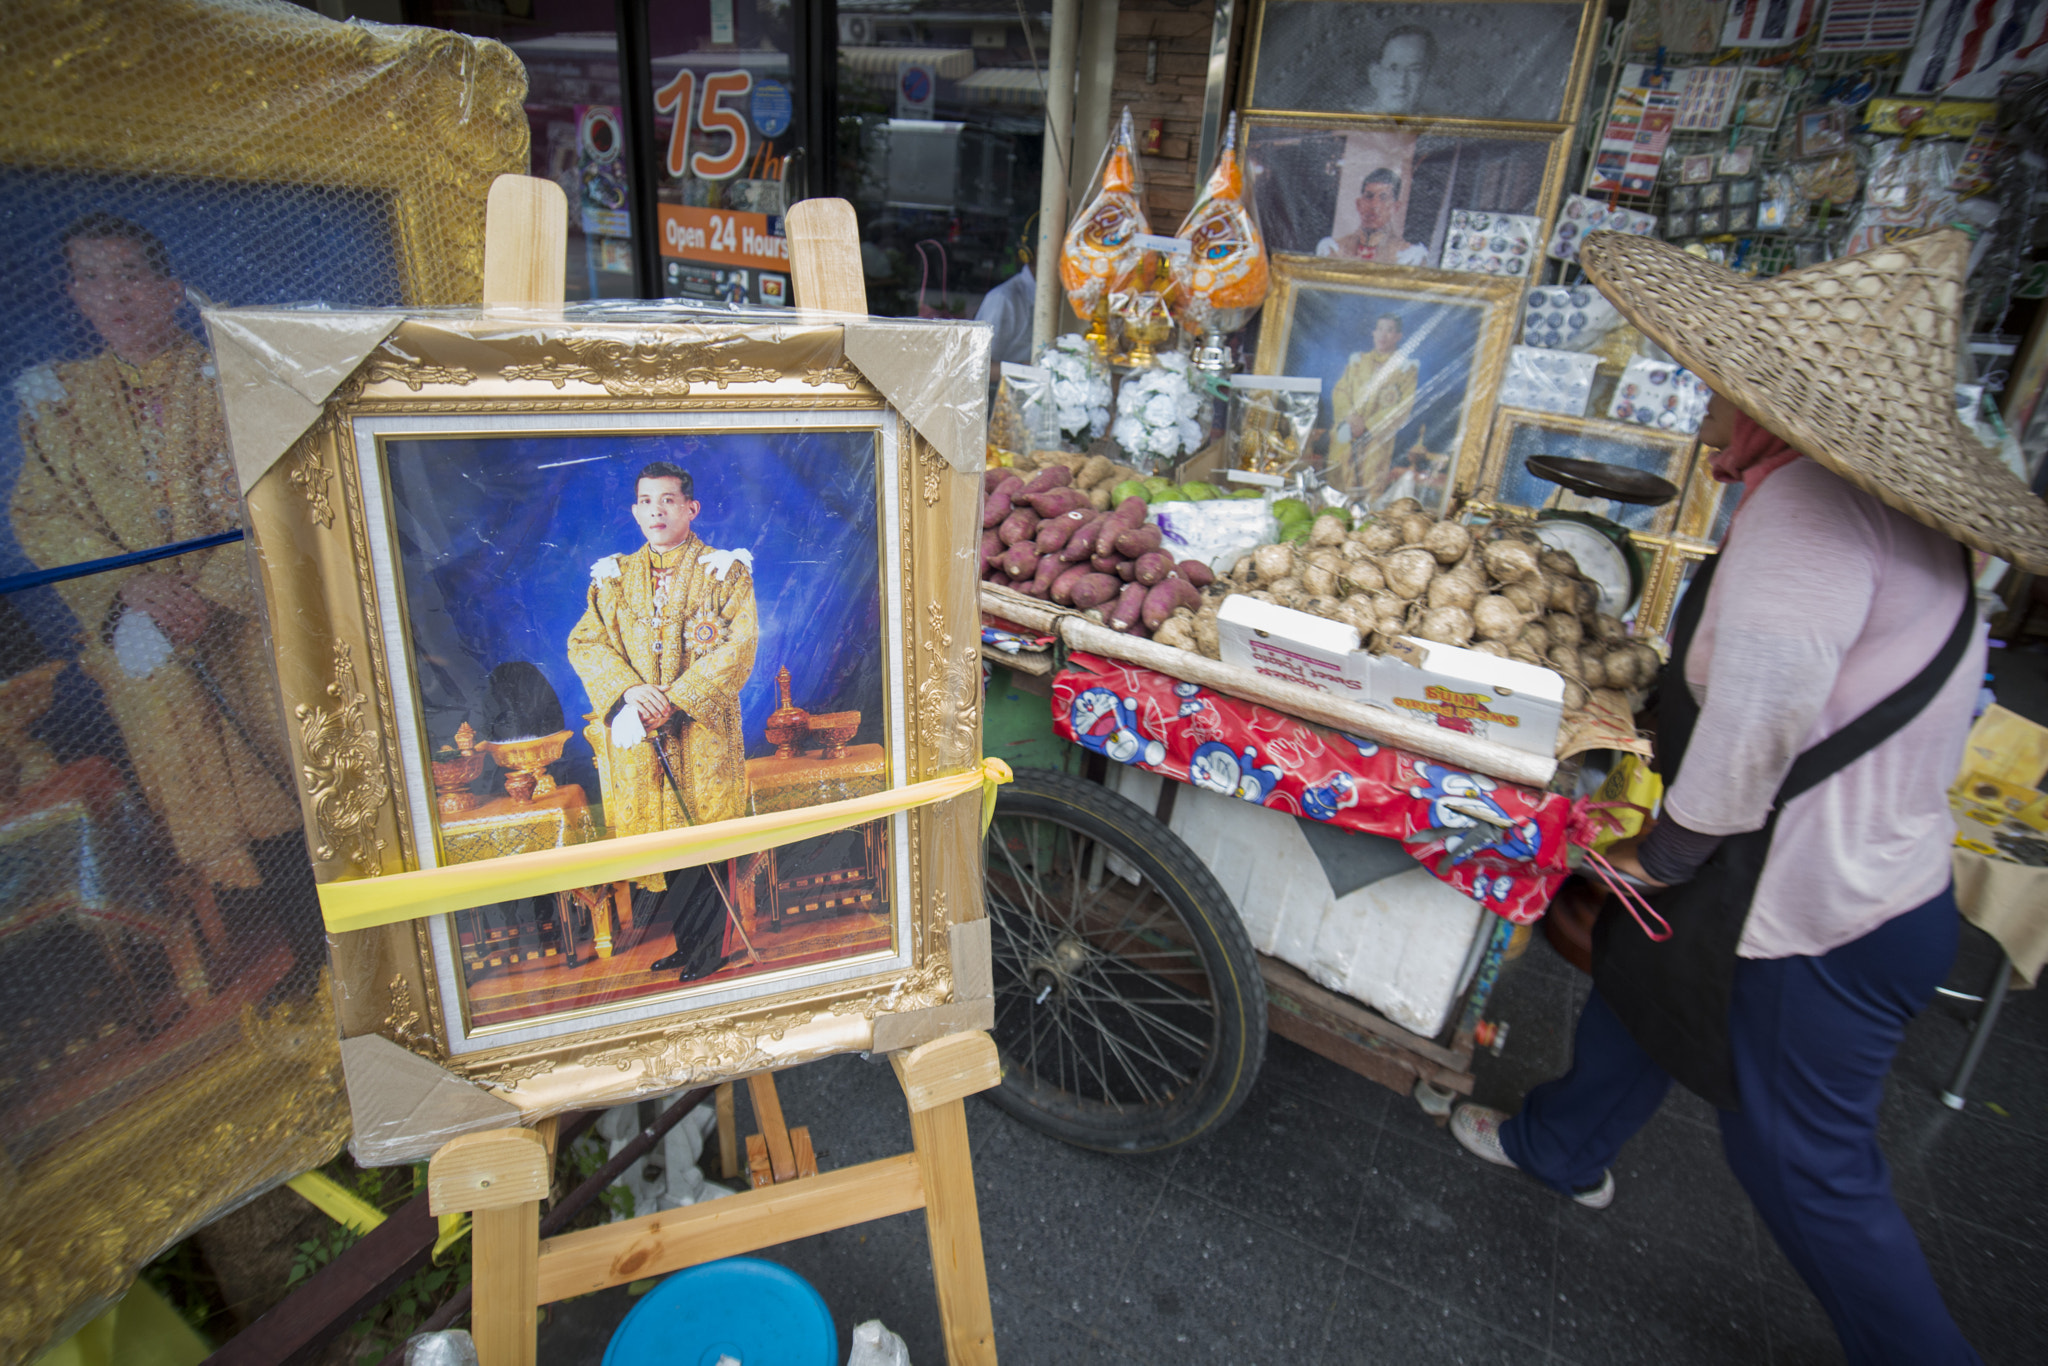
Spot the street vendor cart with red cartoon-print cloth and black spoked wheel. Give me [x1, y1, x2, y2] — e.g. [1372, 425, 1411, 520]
[981, 586, 1573, 1151]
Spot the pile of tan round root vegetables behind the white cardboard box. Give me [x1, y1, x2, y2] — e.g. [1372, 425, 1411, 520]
[1194, 498, 1663, 715]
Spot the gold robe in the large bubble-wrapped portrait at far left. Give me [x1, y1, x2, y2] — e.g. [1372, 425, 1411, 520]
[12, 336, 299, 887]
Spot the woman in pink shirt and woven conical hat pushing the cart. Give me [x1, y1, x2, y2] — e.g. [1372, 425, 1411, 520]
[1452, 233, 2048, 1366]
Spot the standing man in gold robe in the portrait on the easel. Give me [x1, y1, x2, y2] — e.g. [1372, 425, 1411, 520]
[569, 461, 760, 981]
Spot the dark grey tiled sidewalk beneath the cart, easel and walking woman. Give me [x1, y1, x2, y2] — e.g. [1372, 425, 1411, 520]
[541, 930, 2048, 1366]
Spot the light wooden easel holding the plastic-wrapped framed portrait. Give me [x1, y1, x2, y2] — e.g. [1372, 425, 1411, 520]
[428, 176, 1001, 1366]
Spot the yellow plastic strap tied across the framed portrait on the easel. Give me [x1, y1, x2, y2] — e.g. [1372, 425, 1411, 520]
[319, 760, 1010, 934]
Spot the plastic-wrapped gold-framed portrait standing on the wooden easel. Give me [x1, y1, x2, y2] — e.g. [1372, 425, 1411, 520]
[226, 309, 987, 1122]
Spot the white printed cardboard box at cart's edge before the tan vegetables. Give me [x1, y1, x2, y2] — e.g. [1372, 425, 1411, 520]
[1217, 594, 1565, 756]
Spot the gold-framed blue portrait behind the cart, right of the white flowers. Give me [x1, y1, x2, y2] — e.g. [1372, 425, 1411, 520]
[1253, 254, 1522, 512]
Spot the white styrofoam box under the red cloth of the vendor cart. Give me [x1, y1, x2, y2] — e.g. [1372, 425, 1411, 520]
[1110, 766, 1493, 1036]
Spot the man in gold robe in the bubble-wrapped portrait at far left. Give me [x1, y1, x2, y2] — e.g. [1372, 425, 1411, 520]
[12, 213, 299, 889]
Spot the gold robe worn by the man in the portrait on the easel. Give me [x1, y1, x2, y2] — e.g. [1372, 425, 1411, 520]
[569, 535, 760, 887]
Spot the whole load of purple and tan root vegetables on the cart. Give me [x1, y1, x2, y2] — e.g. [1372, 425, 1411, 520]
[981, 464, 1663, 717]
